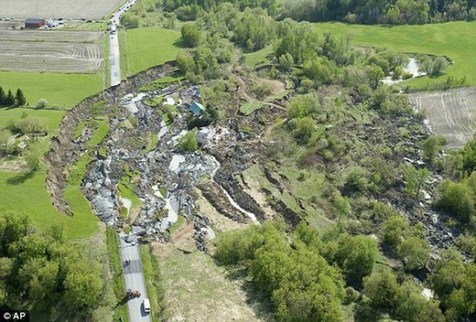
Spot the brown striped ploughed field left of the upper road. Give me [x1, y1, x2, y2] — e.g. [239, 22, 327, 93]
[0, 30, 103, 73]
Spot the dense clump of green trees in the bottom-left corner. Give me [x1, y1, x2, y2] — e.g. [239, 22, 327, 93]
[0, 213, 104, 317]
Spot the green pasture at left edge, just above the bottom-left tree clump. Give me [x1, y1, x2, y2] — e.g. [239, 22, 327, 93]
[0, 172, 98, 239]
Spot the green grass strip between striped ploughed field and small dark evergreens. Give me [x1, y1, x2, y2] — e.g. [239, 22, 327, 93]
[0, 72, 103, 109]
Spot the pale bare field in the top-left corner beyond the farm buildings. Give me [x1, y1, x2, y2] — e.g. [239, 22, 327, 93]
[0, 0, 124, 19]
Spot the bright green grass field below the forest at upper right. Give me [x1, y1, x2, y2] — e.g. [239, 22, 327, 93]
[315, 21, 476, 89]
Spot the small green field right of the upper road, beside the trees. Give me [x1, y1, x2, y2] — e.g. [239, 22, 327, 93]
[120, 27, 180, 76]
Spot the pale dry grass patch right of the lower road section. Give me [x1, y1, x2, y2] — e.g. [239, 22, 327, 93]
[152, 236, 262, 322]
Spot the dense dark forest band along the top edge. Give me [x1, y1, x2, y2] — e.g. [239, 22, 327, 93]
[158, 0, 476, 25]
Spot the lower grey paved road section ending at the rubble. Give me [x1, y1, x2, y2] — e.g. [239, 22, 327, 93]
[119, 235, 151, 322]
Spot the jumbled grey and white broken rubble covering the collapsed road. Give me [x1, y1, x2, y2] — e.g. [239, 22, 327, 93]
[79, 81, 263, 250]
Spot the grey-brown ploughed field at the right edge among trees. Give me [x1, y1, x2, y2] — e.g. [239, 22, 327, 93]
[409, 87, 476, 149]
